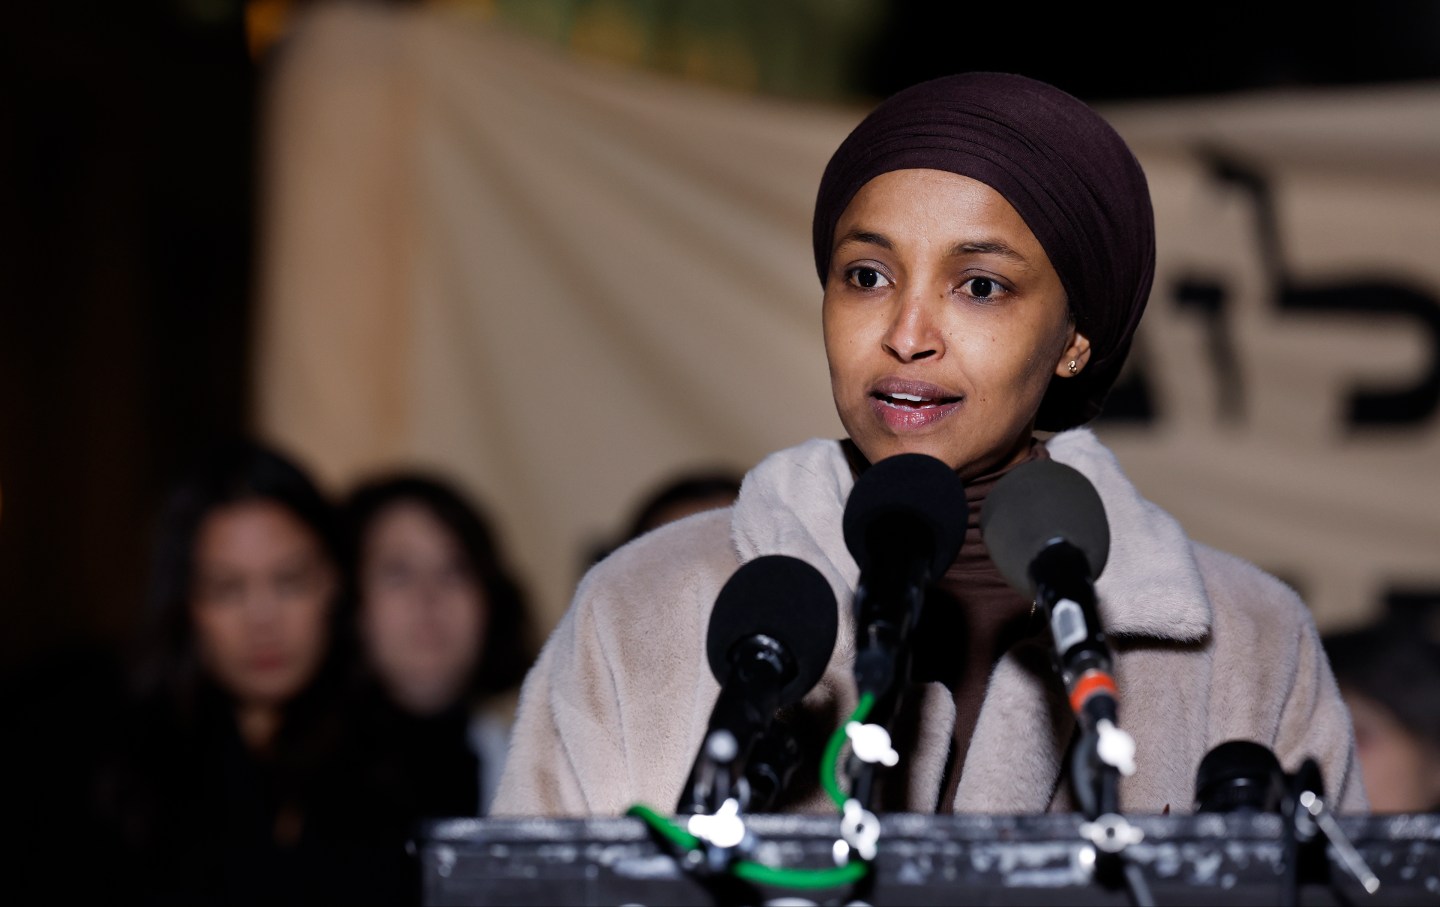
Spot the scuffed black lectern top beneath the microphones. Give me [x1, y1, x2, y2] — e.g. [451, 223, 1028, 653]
[416, 813, 1440, 907]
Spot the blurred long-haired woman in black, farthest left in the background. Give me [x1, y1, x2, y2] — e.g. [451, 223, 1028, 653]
[96, 441, 410, 904]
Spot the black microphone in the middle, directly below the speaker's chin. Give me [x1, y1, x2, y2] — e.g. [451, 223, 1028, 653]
[842, 454, 969, 700]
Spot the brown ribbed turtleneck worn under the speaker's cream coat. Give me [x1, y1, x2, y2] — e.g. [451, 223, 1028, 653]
[841, 438, 1050, 812]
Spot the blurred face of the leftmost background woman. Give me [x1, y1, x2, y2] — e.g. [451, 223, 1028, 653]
[190, 501, 337, 707]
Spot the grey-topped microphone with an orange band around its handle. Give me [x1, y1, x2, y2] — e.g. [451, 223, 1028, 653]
[981, 459, 1128, 737]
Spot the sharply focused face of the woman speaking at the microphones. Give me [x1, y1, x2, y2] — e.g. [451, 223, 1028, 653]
[824, 170, 1090, 479]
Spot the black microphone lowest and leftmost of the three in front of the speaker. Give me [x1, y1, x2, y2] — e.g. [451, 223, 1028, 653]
[677, 554, 840, 813]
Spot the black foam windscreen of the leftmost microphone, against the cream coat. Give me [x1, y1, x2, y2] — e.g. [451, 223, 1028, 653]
[706, 554, 840, 705]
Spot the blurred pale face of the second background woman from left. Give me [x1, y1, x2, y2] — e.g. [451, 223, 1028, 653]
[359, 501, 490, 714]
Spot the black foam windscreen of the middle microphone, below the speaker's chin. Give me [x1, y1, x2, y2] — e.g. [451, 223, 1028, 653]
[844, 454, 971, 576]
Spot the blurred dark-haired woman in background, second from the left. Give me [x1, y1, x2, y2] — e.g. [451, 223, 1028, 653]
[344, 472, 534, 822]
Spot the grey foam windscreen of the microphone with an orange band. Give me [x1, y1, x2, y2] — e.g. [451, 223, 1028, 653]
[981, 459, 1110, 597]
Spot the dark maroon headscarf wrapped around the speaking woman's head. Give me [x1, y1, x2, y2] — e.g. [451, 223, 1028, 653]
[814, 72, 1155, 432]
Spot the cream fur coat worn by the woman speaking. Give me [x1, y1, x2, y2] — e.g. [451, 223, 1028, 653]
[494, 429, 1367, 816]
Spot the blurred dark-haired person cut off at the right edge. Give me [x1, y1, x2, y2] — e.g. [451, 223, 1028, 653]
[1323, 616, 1440, 812]
